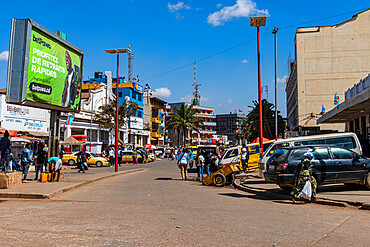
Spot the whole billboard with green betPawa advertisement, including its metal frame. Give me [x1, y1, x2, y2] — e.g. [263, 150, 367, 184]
[6, 19, 83, 112]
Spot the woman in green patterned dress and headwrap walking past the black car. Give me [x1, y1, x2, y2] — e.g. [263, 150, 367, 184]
[291, 151, 317, 203]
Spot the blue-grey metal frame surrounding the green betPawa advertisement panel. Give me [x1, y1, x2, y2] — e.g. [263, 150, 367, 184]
[6, 18, 84, 112]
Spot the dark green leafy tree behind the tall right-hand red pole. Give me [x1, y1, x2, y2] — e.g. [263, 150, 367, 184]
[245, 99, 285, 141]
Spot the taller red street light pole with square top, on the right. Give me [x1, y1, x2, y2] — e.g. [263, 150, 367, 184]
[250, 16, 266, 153]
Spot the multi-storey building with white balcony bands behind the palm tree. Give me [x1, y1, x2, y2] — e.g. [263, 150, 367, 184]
[166, 102, 216, 144]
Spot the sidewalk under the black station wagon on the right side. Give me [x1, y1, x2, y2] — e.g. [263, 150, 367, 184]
[234, 174, 370, 210]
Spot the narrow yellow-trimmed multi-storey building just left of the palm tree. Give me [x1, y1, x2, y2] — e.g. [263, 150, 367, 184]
[144, 92, 167, 145]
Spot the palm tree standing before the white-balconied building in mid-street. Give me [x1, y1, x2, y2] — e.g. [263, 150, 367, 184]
[166, 103, 203, 146]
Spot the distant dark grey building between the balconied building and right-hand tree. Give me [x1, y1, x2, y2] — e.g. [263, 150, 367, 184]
[216, 112, 246, 143]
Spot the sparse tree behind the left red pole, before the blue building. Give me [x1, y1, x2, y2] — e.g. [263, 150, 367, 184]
[94, 99, 138, 131]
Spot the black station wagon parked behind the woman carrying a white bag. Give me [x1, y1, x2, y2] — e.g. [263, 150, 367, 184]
[264, 145, 370, 189]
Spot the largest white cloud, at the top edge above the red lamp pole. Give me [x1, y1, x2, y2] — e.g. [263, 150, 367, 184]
[207, 0, 269, 26]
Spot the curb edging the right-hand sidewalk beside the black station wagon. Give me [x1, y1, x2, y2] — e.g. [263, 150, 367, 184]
[233, 180, 370, 210]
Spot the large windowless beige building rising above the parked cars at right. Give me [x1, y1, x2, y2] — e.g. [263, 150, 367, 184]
[285, 9, 370, 131]
